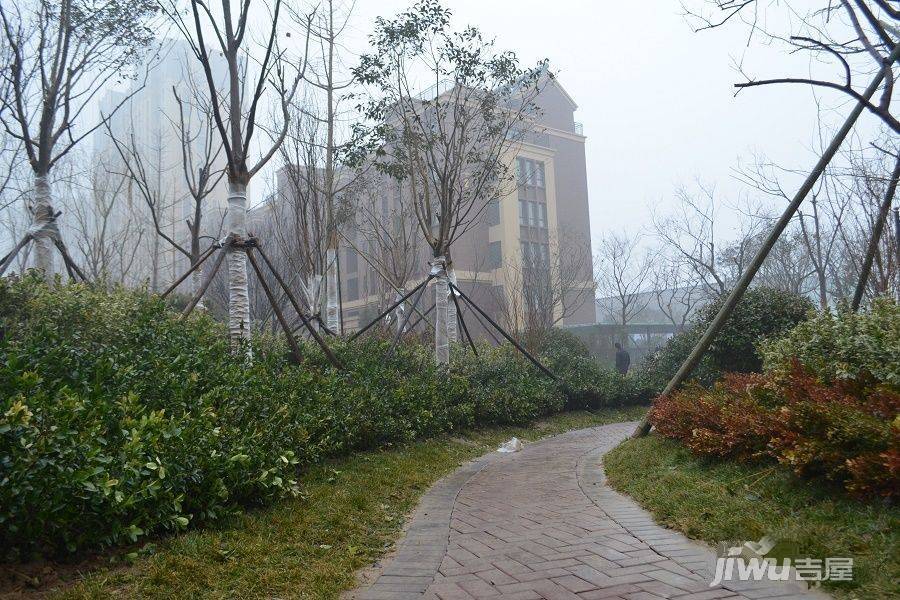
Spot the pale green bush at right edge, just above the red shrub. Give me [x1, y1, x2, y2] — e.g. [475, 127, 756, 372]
[762, 298, 900, 391]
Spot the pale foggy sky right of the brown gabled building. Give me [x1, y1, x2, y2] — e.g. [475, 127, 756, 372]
[348, 0, 874, 242]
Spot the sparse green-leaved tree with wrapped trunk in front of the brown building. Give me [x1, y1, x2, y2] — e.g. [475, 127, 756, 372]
[355, 0, 549, 364]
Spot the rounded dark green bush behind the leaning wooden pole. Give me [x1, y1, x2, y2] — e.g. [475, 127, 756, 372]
[643, 287, 814, 393]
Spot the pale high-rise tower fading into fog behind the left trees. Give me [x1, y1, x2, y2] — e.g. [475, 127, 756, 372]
[94, 39, 227, 289]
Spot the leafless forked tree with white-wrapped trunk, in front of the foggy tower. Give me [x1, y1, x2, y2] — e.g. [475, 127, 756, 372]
[163, 0, 309, 342]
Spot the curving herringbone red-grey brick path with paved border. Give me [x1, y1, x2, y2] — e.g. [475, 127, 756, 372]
[353, 423, 828, 600]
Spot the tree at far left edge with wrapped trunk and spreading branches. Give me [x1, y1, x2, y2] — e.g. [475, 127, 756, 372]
[0, 0, 156, 280]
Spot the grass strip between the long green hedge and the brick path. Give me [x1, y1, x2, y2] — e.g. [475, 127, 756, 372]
[37, 407, 645, 598]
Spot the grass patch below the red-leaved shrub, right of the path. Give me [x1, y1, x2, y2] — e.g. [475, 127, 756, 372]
[604, 435, 900, 599]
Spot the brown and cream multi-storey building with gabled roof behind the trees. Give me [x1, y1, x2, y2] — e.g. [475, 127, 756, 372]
[340, 78, 595, 336]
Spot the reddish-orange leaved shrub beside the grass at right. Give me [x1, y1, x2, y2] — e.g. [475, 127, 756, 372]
[650, 365, 900, 496]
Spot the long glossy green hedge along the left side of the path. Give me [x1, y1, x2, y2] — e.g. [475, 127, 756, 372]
[0, 277, 647, 557]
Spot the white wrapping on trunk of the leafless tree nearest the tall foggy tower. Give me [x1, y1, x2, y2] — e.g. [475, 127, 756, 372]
[228, 182, 250, 343]
